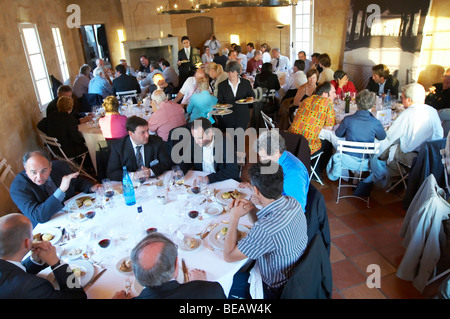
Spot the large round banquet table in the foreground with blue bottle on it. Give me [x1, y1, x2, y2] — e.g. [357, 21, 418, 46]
[33, 171, 255, 299]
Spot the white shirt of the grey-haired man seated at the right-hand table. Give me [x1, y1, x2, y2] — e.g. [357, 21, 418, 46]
[386, 104, 444, 153]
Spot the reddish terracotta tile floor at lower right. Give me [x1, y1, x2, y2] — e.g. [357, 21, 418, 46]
[313, 177, 442, 299]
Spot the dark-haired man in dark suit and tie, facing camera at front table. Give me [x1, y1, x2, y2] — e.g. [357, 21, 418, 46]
[107, 116, 172, 181]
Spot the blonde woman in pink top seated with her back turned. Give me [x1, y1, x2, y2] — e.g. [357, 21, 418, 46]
[98, 95, 128, 140]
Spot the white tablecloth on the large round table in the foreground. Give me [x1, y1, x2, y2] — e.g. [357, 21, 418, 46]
[33, 171, 251, 299]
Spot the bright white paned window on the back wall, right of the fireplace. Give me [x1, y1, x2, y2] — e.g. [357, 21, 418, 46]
[292, 0, 314, 59]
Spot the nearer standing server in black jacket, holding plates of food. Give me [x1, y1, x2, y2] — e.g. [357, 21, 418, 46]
[217, 61, 255, 131]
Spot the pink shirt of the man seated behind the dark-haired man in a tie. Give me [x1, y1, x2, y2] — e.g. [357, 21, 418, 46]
[148, 101, 186, 142]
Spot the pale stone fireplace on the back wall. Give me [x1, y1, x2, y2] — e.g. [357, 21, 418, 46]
[123, 37, 179, 71]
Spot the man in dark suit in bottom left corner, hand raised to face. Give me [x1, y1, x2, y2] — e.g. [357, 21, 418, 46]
[0, 214, 87, 299]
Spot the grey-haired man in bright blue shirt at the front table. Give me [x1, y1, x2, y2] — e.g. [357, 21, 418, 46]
[240, 130, 309, 211]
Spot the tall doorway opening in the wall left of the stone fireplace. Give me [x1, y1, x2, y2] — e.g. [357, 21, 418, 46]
[79, 24, 111, 69]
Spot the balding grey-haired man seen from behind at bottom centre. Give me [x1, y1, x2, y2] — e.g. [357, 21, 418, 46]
[113, 233, 226, 299]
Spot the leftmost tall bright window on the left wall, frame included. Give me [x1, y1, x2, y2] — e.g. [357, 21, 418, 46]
[19, 23, 53, 110]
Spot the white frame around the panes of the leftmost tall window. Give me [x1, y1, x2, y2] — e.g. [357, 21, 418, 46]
[18, 23, 53, 111]
